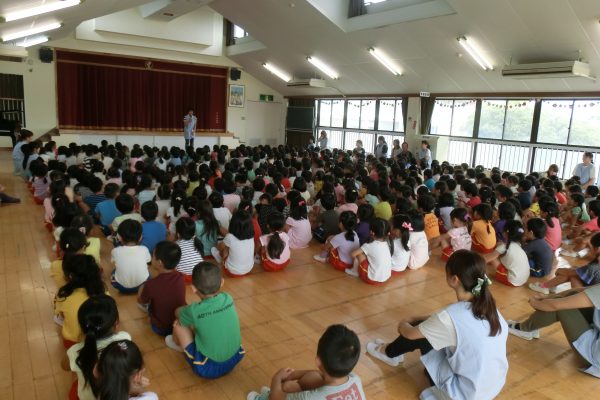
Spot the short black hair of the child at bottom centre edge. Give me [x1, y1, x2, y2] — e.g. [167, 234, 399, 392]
[317, 325, 360, 378]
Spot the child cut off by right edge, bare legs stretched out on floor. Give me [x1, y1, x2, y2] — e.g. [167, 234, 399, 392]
[529, 233, 600, 294]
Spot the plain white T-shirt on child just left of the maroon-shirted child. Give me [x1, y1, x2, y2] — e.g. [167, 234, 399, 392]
[111, 246, 152, 288]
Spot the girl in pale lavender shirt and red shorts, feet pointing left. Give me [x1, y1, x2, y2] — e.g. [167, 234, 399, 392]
[313, 211, 360, 271]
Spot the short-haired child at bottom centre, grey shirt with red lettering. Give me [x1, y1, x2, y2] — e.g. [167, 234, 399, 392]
[247, 325, 366, 400]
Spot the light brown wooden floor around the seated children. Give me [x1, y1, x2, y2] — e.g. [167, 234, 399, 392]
[0, 151, 600, 400]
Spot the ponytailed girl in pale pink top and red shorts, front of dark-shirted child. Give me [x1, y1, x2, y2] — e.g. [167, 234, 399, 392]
[259, 212, 290, 272]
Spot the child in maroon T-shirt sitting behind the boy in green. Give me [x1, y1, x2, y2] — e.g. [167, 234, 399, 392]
[137, 240, 186, 336]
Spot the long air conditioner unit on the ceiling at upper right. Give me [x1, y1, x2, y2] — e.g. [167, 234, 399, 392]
[502, 61, 596, 80]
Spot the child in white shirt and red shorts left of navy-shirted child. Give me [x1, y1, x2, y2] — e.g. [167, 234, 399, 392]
[486, 220, 529, 286]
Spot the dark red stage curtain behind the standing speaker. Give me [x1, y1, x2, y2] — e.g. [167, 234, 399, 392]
[56, 50, 228, 132]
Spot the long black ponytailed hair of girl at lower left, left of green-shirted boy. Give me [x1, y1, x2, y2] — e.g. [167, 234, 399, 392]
[75, 294, 119, 393]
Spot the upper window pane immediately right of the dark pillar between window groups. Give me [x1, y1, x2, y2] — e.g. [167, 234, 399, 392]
[430, 100, 477, 137]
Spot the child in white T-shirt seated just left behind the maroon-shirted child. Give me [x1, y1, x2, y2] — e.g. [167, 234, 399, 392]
[111, 219, 152, 294]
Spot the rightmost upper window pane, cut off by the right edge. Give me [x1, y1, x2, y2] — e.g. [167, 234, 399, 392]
[563, 100, 600, 146]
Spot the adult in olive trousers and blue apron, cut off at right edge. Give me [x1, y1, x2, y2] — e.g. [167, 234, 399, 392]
[508, 285, 600, 378]
